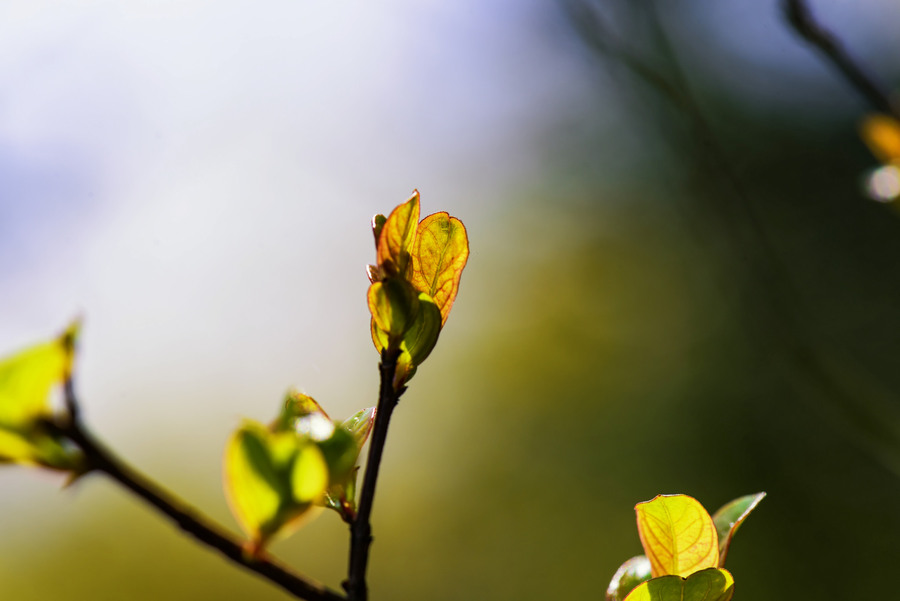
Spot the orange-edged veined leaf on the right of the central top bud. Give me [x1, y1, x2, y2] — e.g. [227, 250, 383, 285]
[409, 212, 469, 325]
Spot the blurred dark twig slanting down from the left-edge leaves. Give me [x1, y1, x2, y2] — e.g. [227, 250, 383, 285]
[50, 379, 344, 601]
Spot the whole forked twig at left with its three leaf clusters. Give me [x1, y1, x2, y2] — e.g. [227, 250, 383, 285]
[0, 192, 469, 599]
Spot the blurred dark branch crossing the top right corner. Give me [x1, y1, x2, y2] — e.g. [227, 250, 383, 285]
[782, 0, 900, 119]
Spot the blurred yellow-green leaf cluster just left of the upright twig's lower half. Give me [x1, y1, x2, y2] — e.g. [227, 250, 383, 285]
[225, 391, 375, 553]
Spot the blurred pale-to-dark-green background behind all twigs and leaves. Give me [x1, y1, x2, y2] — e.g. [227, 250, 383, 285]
[0, 0, 900, 601]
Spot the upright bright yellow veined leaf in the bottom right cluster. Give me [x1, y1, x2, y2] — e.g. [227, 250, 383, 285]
[634, 495, 719, 578]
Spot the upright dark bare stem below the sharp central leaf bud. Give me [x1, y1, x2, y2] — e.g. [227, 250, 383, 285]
[344, 349, 406, 601]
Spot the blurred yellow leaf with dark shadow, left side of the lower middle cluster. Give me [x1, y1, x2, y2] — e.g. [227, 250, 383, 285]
[224, 420, 328, 548]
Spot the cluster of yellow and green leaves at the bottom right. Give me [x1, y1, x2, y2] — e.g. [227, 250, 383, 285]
[606, 493, 766, 601]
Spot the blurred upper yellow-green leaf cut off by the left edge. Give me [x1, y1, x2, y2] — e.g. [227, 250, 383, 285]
[0, 323, 78, 429]
